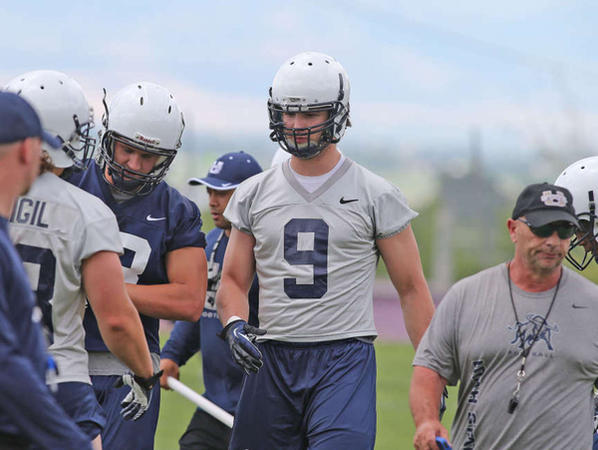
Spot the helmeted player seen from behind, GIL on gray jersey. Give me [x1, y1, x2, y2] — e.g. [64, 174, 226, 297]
[6, 70, 153, 446]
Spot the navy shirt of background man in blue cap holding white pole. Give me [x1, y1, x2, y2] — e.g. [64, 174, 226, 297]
[162, 228, 258, 414]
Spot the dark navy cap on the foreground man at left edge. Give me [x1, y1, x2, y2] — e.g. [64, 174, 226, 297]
[0, 91, 62, 148]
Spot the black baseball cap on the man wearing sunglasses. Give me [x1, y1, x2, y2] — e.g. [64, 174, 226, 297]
[511, 183, 579, 227]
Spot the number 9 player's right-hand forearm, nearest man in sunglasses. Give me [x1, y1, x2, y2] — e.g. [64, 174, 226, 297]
[399, 280, 435, 349]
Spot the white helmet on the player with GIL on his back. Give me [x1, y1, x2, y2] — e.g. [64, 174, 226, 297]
[5, 70, 96, 168]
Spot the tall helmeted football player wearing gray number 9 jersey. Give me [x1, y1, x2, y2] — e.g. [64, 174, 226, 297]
[216, 52, 434, 449]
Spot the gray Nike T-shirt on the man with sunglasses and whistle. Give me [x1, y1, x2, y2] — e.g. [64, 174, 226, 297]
[413, 264, 598, 450]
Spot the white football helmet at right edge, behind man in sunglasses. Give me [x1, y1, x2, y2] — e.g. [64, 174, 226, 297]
[554, 156, 598, 270]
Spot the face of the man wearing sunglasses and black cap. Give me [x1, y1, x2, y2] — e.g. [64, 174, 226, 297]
[508, 219, 570, 275]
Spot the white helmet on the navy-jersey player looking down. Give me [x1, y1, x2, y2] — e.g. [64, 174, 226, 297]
[99, 81, 185, 195]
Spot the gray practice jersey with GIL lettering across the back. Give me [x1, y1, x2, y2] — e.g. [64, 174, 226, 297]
[10, 173, 123, 383]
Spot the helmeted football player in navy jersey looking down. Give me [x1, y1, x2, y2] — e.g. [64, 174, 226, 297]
[70, 82, 207, 450]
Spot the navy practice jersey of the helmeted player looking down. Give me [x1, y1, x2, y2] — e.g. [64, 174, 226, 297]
[69, 162, 205, 353]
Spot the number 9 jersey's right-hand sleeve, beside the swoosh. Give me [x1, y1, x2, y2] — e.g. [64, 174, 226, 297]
[373, 186, 417, 239]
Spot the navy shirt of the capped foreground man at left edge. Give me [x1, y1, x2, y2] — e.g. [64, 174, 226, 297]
[0, 217, 89, 449]
